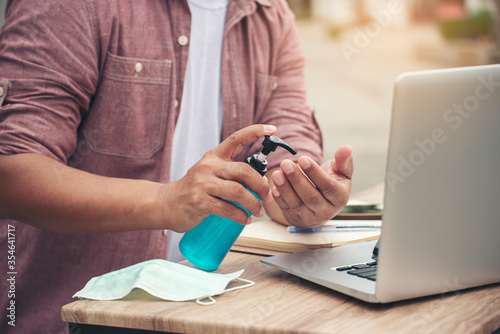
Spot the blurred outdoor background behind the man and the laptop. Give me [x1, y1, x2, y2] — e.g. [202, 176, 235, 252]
[0, 0, 500, 193]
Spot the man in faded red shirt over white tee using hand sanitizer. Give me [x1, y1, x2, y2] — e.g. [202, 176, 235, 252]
[0, 0, 353, 333]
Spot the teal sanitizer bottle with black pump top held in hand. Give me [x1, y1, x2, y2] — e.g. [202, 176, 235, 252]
[179, 136, 297, 271]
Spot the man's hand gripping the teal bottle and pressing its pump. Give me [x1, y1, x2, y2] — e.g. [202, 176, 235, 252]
[158, 125, 276, 232]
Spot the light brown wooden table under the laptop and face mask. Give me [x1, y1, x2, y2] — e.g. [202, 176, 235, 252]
[62, 252, 500, 334]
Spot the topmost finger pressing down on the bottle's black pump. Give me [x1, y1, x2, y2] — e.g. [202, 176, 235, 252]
[214, 124, 276, 161]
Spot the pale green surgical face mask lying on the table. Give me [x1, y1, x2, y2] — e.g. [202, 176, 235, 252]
[73, 259, 255, 305]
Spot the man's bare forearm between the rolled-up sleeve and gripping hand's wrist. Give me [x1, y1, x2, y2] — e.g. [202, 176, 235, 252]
[0, 154, 164, 233]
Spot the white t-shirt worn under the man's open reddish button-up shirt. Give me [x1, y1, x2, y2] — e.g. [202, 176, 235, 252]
[167, 0, 228, 261]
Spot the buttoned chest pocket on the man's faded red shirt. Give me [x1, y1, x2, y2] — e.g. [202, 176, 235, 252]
[83, 53, 172, 159]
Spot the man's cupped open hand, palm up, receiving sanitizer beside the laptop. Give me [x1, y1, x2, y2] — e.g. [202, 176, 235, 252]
[266, 145, 354, 227]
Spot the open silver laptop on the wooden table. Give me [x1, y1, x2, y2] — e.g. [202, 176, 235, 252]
[261, 65, 500, 303]
